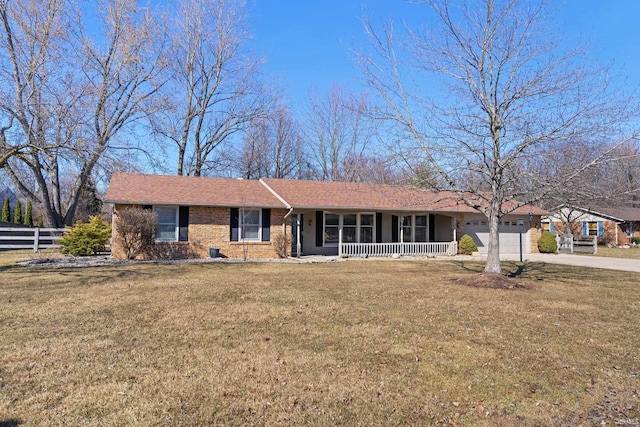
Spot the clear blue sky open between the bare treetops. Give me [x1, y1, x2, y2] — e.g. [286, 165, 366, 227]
[249, 0, 640, 105]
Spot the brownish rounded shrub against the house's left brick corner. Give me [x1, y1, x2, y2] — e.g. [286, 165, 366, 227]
[115, 208, 158, 259]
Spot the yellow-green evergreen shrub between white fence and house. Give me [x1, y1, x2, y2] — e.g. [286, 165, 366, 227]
[60, 216, 111, 256]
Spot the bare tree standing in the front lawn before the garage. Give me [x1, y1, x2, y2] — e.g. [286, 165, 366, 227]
[359, 0, 630, 273]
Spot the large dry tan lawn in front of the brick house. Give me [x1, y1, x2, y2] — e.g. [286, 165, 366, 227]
[0, 254, 640, 426]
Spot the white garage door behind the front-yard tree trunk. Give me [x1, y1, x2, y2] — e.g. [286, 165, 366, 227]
[464, 219, 531, 254]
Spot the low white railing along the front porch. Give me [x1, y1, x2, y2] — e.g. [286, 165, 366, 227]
[338, 241, 458, 257]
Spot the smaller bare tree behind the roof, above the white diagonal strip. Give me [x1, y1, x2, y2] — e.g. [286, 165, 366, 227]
[238, 105, 306, 179]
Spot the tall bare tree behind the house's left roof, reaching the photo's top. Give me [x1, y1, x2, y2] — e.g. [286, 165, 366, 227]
[152, 0, 268, 176]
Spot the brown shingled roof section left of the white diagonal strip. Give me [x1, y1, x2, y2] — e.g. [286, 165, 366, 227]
[105, 173, 284, 208]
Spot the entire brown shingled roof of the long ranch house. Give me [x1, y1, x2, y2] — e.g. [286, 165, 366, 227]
[105, 173, 546, 215]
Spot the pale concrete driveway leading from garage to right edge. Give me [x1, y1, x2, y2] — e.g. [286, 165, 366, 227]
[500, 254, 640, 272]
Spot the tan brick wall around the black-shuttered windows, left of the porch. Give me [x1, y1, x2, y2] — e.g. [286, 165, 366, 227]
[112, 205, 291, 259]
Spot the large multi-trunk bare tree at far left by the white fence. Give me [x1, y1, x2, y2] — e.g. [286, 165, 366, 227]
[0, 0, 168, 226]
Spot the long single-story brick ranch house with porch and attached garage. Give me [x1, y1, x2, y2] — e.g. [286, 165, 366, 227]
[106, 173, 546, 258]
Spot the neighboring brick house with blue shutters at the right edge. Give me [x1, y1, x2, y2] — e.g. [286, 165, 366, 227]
[542, 206, 640, 245]
